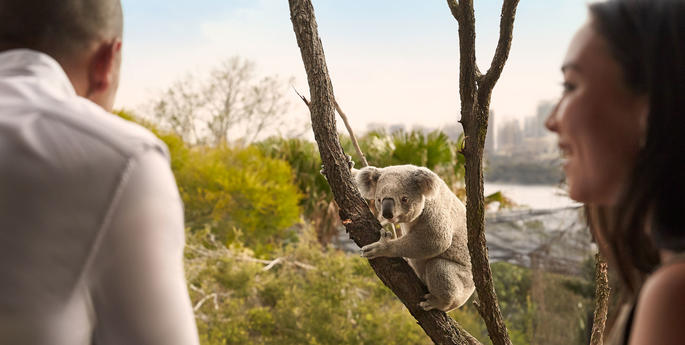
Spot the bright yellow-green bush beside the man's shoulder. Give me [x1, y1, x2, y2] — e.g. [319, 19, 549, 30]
[119, 112, 301, 255]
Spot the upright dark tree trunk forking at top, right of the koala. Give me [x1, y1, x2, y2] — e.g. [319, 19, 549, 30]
[447, 0, 519, 345]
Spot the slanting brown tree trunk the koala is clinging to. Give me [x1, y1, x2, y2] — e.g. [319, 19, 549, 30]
[288, 0, 479, 344]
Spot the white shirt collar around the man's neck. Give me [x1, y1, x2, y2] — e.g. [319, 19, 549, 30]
[0, 49, 76, 95]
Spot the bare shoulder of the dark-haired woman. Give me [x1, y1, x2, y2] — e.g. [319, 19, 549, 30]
[630, 260, 685, 344]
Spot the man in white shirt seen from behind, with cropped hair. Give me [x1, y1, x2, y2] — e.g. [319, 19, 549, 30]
[0, 0, 198, 345]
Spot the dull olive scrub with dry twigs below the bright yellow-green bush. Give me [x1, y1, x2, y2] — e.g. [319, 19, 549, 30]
[186, 226, 431, 345]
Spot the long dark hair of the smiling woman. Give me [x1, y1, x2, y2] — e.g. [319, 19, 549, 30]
[590, 0, 685, 294]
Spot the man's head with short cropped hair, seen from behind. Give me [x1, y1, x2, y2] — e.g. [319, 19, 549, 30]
[0, 0, 123, 110]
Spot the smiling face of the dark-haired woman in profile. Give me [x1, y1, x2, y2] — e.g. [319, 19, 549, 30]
[545, 22, 648, 205]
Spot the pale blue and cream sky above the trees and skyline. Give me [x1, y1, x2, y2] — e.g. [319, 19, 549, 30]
[116, 0, 587, 134]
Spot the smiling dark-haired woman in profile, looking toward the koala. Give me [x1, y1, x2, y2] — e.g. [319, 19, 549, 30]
[546, 0, 685, 344]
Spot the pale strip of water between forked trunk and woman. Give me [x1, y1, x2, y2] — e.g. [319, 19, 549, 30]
[484, 183, 580, 209]
